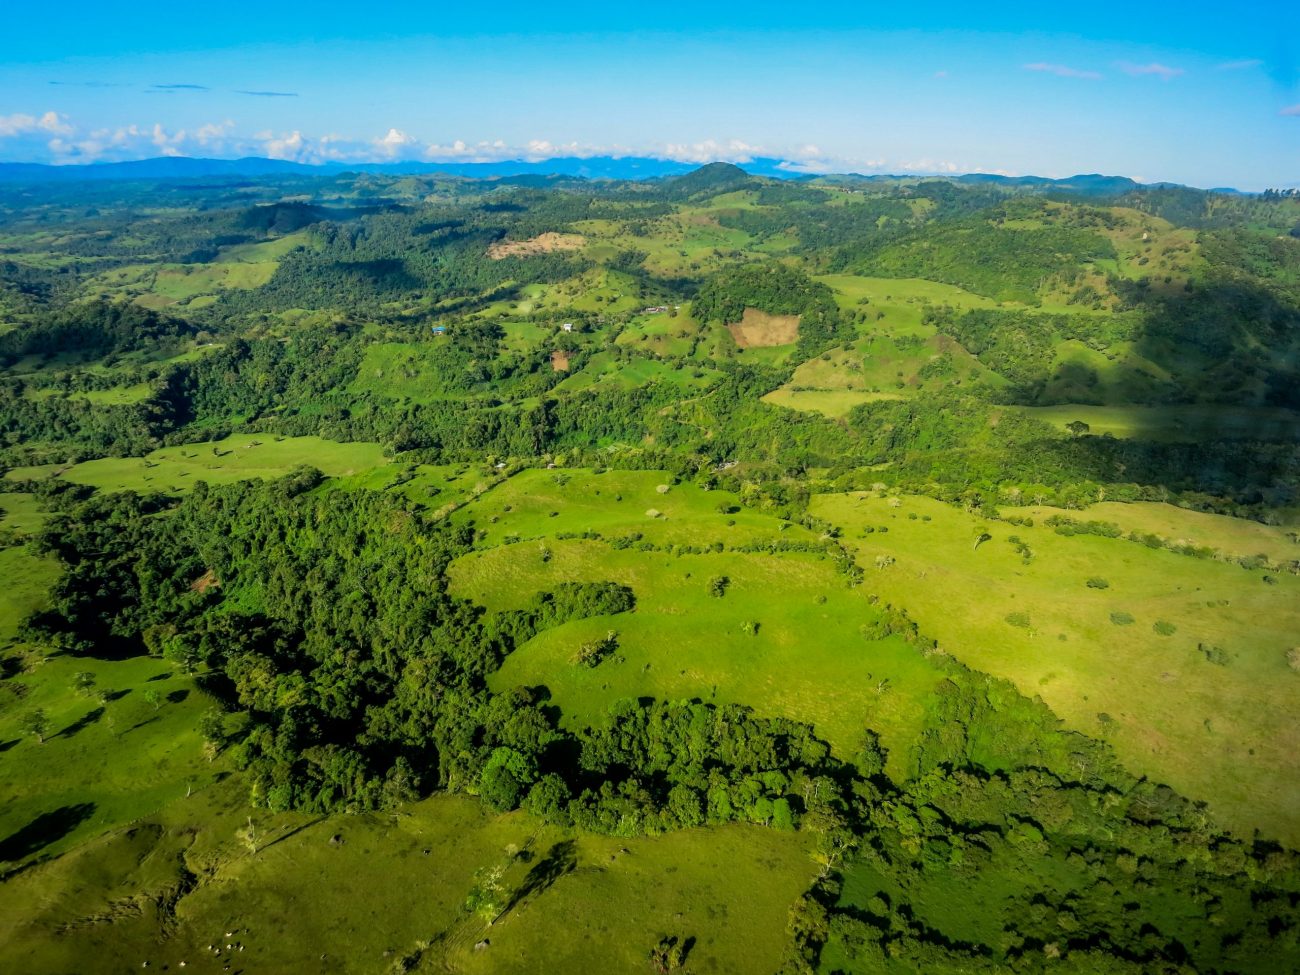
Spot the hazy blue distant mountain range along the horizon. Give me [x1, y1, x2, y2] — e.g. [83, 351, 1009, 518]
[0, 156, 1239, 196]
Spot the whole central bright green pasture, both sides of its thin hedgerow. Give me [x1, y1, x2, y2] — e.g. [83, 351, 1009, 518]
[451, 471, 940, 775]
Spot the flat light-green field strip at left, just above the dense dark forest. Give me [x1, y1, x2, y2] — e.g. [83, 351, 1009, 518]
[0, 433, 389, 496]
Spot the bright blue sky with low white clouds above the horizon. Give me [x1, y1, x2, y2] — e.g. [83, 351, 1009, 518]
[0, 0, 1300, 189]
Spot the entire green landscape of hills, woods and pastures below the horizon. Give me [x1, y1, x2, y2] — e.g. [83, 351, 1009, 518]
[0, 166, 1300, 972]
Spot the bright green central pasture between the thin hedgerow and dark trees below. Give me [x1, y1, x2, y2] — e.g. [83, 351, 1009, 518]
[451, 541, 940, 776]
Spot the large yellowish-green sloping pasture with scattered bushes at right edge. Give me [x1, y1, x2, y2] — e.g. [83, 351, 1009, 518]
[814, 494, 1300, 844]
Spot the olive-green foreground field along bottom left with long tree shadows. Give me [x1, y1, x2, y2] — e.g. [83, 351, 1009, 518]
[0, 776, 815, 975]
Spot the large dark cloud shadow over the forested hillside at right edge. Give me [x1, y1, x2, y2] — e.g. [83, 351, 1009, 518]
[987, 281, 1300, 506]
